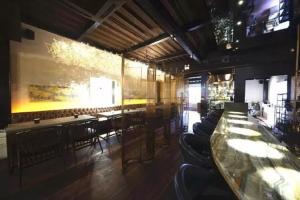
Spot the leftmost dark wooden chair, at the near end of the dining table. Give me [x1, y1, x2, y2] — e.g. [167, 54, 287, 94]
[16, 127, 63, 186]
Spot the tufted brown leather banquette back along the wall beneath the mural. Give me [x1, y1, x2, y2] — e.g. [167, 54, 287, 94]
[12, 104, 145, 123]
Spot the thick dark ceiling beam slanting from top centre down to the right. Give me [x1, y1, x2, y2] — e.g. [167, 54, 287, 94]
[136, 0, 201, 62]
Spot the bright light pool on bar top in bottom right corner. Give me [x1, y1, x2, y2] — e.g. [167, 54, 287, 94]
[258, 167, 300, 199]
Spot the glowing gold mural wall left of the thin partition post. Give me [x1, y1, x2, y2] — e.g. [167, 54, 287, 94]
[10, 24, 122, 113]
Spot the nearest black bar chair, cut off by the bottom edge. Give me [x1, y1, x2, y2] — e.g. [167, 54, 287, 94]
[174, 164, 236, 200]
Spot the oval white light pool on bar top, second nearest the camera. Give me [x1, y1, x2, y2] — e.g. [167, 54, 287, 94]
[227, 139, 284, 159]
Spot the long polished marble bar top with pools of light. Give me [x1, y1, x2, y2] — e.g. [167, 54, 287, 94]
[211, 111, 300, 200]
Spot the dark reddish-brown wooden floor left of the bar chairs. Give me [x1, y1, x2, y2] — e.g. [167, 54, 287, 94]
[0, 135, 181, 200]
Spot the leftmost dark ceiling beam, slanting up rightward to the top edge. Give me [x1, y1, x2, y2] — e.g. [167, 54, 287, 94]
[78, 0, 128, 40]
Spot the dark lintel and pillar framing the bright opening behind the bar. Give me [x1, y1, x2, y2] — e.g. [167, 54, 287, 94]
[234, 62, 294, 102]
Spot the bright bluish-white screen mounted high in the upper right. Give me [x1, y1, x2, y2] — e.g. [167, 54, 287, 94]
[244, 0, 290, 37]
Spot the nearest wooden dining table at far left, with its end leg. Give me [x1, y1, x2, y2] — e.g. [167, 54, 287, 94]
[5, 115, 97, 169]
